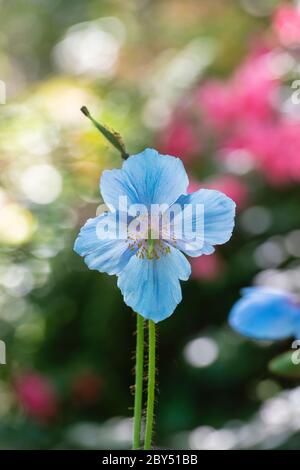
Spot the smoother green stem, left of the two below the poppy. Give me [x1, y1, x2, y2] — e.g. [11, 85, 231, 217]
[132, 313, 144, 449]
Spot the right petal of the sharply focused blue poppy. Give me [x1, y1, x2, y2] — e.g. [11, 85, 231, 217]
[171, 189, 235, 256]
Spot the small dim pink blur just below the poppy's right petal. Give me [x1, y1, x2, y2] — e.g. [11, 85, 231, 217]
[189, 252, 223, 281]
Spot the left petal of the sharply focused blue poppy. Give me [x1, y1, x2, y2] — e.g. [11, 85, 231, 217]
[74, 213, 133, 274]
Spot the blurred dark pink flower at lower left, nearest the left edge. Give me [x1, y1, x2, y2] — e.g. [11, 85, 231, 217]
[15, 372, 58, 423]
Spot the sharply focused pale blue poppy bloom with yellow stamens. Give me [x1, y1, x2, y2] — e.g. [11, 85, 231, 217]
[74, 149, 235, 322]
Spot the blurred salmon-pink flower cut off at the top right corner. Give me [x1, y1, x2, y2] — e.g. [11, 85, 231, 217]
[273, 5, 300, 47]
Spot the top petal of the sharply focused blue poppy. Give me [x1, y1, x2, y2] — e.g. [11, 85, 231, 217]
[100, 149, 188, 209]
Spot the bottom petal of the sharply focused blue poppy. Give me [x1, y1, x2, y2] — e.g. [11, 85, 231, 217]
[118, 247, 191, 322]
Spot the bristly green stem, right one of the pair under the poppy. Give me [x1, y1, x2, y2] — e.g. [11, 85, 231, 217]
[144, 320, 155, 450]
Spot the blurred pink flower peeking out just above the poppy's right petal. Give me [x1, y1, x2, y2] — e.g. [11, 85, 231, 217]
[188, 175, 249, 209]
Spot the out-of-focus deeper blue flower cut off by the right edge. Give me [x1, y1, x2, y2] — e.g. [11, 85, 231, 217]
[229, 287, 300, 340]
